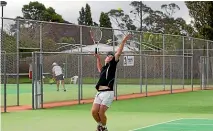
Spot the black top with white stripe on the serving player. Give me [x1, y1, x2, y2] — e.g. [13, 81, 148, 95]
[96, 57, 119, 91]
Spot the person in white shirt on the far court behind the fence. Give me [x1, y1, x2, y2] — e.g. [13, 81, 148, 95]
[52, 62, 66, 91]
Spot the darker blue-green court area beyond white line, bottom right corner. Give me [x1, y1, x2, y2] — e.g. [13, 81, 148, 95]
[131, 118, 213, 131]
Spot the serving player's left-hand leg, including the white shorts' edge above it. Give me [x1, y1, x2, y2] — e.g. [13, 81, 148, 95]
[91, 92, 102, 131]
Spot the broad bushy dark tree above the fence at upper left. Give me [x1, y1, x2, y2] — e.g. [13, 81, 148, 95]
[22, 1, 64, 22]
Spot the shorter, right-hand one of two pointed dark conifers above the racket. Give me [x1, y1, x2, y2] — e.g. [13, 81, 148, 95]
[99, 12, 112, 28]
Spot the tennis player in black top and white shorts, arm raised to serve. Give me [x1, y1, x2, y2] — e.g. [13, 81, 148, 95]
[92, 35, 131, 131]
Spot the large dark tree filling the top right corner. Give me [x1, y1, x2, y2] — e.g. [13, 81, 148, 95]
[185, 1, 213, 40]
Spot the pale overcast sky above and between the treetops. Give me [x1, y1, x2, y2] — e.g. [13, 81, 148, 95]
[1, 0, 191, 24]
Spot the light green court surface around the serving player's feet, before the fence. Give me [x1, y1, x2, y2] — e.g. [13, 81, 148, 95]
[1, 90, 213, 131]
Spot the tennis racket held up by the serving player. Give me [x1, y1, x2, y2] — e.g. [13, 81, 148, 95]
[90, 27, 102, 54]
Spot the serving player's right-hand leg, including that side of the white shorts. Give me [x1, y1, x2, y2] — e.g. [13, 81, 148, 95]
[99, 91, 114, 131]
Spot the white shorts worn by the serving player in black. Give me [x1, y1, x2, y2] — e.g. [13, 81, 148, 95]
[94, 91, 114, 107]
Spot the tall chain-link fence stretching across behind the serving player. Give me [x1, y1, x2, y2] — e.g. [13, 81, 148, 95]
[1, 18, 213, 111]
